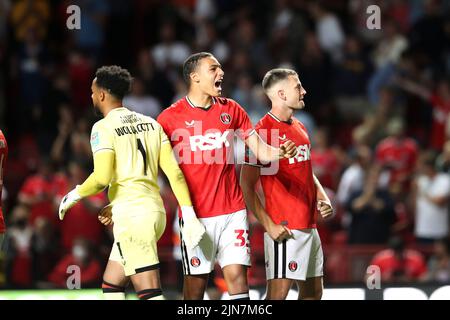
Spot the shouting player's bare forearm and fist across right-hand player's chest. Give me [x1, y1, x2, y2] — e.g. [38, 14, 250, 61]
[245, 132, 297, 162]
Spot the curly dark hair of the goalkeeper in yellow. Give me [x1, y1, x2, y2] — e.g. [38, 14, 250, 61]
[95, 66, 133, 100]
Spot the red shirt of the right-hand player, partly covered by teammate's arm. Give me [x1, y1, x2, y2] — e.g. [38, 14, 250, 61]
[246, 112, 317, 230]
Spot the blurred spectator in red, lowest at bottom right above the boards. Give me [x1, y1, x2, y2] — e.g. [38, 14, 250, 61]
[370, 237, 427, 283]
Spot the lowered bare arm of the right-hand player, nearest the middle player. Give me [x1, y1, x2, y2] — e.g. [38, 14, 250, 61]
[240, 165, 292, 241]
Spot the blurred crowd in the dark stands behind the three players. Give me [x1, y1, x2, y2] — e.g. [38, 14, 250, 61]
[0, 0, 450, 288]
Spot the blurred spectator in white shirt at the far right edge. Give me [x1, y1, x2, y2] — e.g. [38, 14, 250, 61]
[413, 151, 450, 244]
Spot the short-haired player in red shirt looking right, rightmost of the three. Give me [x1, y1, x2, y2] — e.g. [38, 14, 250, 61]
[241, 69, 333, 300]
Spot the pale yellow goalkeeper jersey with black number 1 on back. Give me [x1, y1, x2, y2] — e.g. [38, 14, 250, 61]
[91, 107, 169, 212]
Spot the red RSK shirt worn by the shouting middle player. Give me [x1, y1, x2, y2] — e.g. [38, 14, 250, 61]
[158, 97, 253, 218]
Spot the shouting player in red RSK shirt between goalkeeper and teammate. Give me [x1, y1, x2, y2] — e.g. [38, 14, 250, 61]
[158, 52, 296, 300]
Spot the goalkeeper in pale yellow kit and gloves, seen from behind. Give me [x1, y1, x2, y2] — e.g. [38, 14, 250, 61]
[59, 66, 205, 300]
